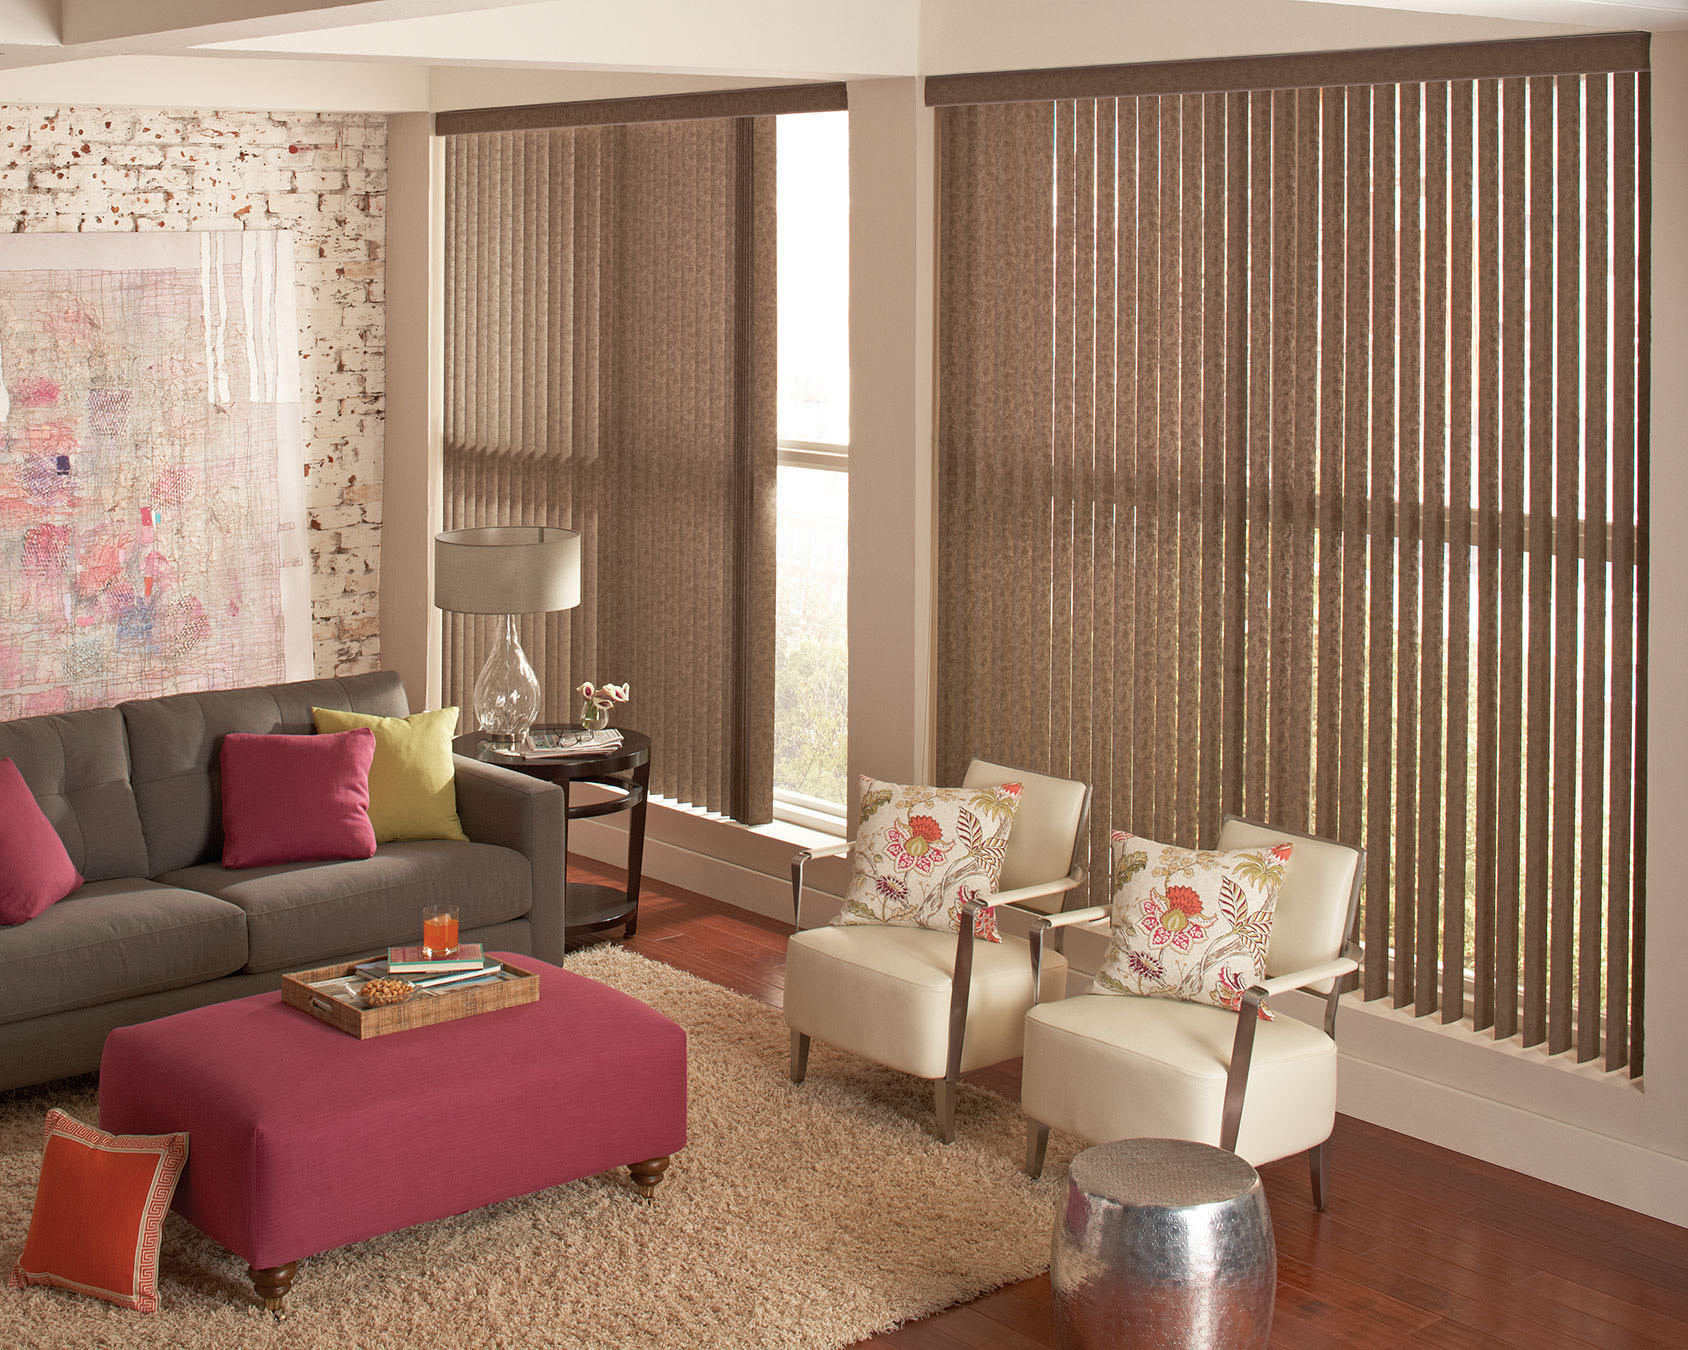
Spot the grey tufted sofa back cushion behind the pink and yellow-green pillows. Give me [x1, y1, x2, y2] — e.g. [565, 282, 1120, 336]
[123, 670, 410, 876]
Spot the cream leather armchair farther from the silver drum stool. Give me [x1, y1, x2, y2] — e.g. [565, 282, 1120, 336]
[785, 759, 1090, 1144]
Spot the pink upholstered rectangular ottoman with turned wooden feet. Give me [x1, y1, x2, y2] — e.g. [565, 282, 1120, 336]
[100, 953, 685, 1311]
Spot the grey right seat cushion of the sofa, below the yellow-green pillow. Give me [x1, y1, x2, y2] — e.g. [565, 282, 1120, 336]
[160, 839, 533, 970]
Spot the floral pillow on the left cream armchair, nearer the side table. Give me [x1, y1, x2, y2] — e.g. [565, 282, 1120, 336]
[834, 775, 1020, 942]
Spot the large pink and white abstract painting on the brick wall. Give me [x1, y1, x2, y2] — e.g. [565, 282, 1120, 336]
[0, 230, 312, 719]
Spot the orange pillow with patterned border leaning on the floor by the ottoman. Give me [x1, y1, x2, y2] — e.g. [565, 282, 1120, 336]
[12, 1110, 187, 1313]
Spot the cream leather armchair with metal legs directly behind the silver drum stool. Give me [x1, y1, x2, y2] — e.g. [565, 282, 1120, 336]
[1020, 817, 1366, 1208]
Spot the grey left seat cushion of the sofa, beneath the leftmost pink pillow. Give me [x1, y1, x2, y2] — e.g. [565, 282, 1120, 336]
[0, 878, 246, 1023]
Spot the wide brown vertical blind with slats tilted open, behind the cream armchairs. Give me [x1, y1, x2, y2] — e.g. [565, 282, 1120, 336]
[928, 35, 1649, 1073]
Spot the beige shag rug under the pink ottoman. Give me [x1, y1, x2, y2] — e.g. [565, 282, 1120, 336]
[0, 947, 1065, 1350]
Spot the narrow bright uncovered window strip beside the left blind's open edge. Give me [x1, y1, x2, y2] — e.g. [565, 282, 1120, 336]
[773, 113, 849, 832]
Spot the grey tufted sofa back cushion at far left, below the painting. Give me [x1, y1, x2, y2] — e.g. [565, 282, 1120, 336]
[0, 707, 151, 881]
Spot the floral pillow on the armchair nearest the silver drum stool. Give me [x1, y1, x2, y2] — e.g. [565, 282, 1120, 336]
[1090, 830, 1295, 1019]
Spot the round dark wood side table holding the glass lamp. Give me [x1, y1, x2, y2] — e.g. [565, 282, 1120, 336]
[451, 724, 650, 942]
